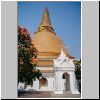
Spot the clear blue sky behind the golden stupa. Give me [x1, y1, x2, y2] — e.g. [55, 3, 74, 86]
[18, 1, 81, 59]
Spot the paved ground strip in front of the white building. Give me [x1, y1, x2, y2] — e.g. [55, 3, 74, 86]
[18, 91, 81, 98]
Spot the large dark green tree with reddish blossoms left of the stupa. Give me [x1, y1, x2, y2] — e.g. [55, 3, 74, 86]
[18, 26, 42, 84]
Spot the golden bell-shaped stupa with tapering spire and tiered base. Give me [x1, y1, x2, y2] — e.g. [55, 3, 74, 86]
[32, 7, 74, 67]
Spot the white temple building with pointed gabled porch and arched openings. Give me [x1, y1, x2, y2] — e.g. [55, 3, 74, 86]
[19, 50, 79, 94]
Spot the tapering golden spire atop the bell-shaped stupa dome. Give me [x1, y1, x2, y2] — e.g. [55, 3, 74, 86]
[37, 6, 54, 32]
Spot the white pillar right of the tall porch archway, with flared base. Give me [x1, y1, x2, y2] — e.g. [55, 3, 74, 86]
[69, 71, 80, 94]
